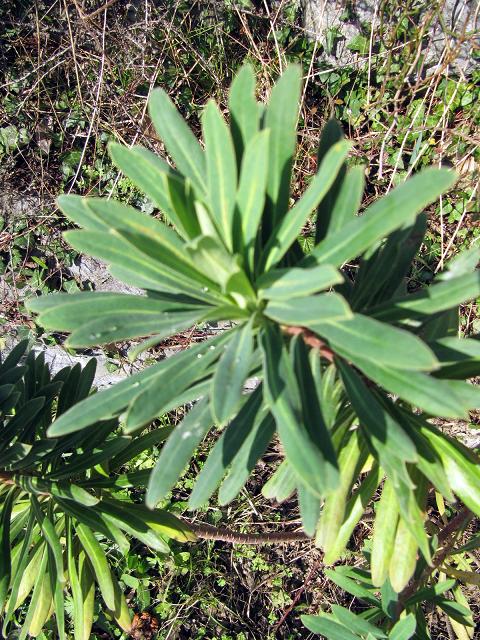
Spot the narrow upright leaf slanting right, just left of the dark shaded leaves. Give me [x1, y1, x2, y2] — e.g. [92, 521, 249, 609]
[263, 142, 351, 271]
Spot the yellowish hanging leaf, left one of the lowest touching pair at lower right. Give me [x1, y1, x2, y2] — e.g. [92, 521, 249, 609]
[370, 478, 398, 587]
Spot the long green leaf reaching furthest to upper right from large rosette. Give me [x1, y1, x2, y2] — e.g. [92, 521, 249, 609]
[304, 169, 456, 267]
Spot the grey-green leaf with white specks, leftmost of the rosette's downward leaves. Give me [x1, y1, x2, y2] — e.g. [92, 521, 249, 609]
[145, 399, 213, 509]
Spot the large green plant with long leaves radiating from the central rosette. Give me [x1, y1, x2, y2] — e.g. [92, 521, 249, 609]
[29, 67, 480, 637]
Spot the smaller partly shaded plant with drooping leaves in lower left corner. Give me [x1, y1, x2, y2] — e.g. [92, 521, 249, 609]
[0, 341, 195, 640]
